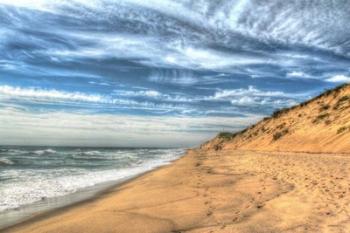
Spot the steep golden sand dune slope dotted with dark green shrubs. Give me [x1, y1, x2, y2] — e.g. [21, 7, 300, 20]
[201, 84, 350, 153]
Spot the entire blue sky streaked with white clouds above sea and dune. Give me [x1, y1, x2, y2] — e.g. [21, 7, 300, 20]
[0, 0, 350, 147]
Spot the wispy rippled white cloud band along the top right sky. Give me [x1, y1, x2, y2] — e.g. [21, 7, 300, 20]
[0, 0, 349, 60]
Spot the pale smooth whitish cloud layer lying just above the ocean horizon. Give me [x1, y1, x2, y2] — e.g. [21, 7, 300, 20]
[0, 107, 261, 146]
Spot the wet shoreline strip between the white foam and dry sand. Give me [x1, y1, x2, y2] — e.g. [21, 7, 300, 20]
[0, 151, 187, 232]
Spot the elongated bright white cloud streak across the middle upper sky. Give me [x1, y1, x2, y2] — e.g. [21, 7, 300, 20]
[46, 32, 274, 70]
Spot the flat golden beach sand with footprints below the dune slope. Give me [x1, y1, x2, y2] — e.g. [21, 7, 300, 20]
[6, 150, 350, 233]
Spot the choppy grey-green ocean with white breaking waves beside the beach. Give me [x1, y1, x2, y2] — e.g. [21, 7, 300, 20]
[0, 146, 185, 228]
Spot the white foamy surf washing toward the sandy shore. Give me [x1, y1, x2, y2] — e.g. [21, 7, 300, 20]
[0, 150, 183, 212]
